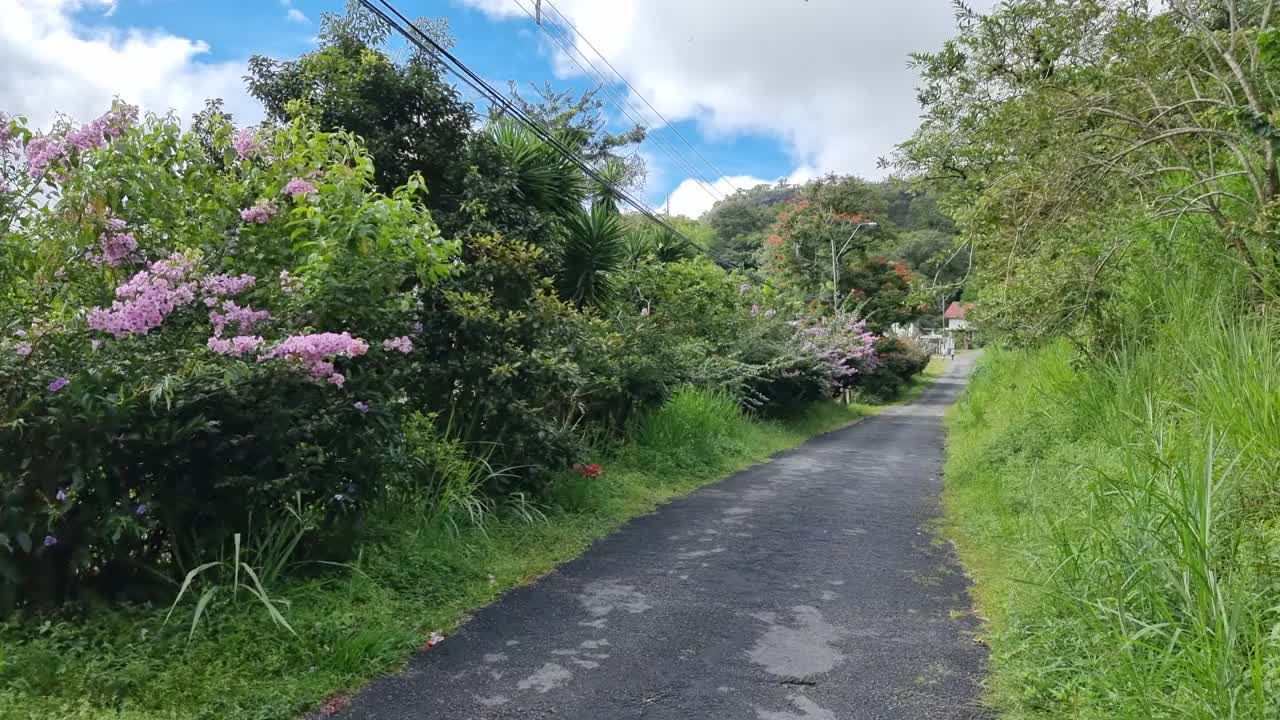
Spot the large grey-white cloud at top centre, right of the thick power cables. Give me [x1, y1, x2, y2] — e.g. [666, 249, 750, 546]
[463, 0, 995, 194]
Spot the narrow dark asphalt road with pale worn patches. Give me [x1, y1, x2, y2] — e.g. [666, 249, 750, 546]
[339, 356, 986, 720]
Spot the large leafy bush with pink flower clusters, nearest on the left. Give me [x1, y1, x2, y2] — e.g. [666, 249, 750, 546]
[0, 104, 458, 607]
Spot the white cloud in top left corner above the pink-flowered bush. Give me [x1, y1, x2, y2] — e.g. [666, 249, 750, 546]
[0, 0, 262, 127]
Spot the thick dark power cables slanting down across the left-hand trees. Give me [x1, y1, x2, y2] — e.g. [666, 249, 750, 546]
[360, 0, 780, 284]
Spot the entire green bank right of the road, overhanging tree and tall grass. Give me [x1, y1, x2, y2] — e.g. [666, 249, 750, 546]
[897, 0, 1280, 720]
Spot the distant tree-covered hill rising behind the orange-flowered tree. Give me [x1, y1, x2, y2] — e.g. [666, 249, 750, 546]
[701, 176, 968, 308]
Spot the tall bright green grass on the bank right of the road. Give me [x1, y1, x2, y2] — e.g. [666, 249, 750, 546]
[945, 283, 1280, 720]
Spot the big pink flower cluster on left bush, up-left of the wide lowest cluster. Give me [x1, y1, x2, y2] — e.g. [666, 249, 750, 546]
[88, 252, 196, 338]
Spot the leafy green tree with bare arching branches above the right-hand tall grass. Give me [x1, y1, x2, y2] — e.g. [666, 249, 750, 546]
[897, 0, 1280, 342]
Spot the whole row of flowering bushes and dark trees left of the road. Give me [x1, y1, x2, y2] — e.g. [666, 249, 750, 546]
[0, 2, 942, 614]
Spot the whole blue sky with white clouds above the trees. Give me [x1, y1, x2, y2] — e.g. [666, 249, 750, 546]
[0, 0, 977, 215]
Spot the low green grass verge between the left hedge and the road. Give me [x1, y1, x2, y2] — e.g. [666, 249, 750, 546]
[0, 379, 931, 720]
